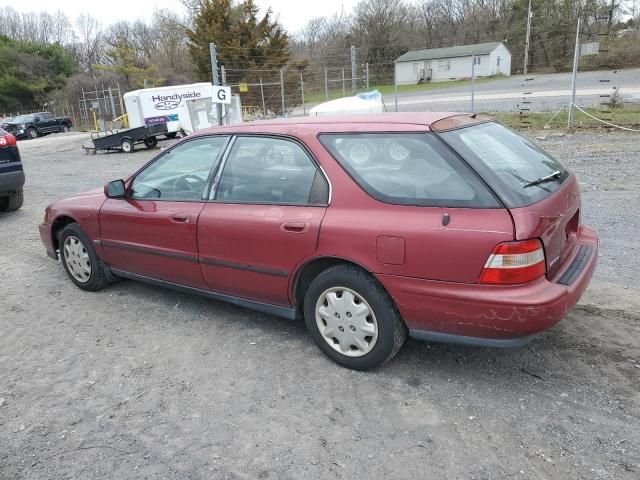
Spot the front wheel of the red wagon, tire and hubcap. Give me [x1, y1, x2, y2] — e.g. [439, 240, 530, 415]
[58, 223, 111, 292]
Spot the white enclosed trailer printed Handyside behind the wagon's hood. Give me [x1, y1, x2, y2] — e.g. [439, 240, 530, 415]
[123, 83, 231, 136]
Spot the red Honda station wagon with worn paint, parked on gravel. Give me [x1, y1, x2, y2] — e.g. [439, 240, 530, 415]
[40, 113, 598, 370]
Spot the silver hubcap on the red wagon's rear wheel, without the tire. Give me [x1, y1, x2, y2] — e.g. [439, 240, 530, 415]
[316, 287, 378, 357]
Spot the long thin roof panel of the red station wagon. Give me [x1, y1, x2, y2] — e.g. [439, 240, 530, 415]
[198, 112, 464, 134]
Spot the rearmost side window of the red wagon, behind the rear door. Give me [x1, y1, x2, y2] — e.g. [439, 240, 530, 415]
[319, 133, 500, 208]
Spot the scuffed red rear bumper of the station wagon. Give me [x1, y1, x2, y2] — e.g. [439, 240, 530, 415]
[377, 226, 598, 346]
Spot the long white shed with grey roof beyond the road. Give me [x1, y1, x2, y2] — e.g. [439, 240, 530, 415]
[395, 42, 511, 85]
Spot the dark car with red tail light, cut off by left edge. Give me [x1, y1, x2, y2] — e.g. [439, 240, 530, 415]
[0, 129, 24, 212]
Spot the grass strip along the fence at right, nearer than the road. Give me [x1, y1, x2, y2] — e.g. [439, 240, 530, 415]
[489, 105, 640, 129]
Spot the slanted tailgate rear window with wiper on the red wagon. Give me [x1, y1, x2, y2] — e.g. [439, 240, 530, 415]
[439, 122, 569, 208]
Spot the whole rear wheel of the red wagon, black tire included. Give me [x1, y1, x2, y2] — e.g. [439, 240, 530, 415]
[304, 265, 407, 370]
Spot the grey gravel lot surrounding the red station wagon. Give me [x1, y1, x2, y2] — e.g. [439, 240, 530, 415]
[0, 132, 640, 480]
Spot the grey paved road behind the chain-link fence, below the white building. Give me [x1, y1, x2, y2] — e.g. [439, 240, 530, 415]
[384, 69, 640, 112]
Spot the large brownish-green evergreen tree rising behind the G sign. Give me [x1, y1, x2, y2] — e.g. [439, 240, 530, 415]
[187, 0, 290, 80]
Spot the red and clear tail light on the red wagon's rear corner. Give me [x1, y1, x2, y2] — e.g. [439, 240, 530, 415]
[480, 240, 546, 285]
